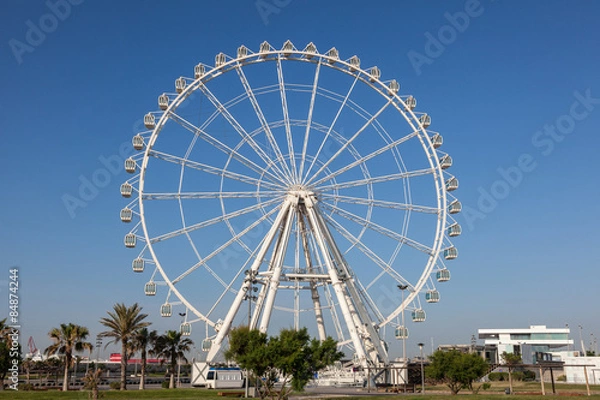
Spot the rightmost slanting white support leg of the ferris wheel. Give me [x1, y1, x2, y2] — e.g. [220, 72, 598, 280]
[315, 200, 389, 365]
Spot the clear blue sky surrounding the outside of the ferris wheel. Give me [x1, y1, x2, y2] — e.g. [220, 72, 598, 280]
[0, 0, 600, 360]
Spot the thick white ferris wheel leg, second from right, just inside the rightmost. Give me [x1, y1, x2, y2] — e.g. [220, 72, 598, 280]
[304, 197, 368, 368]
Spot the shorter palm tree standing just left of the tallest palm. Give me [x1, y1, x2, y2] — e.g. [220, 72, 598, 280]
[45, 323, 92, 391]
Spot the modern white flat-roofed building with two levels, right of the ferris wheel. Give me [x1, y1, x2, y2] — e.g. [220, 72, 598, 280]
[477, 325, 573, 364]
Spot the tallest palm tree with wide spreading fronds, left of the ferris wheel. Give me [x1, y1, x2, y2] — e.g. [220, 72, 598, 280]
[99, 303, 150, 390]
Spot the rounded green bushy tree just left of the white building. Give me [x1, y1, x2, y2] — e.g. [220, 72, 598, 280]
[425, 350, 488, 395]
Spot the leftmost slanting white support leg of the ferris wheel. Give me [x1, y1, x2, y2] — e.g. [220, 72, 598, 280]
[206, 201, 290, 362]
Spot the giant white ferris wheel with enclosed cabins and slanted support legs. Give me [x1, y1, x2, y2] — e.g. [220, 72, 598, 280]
[121, 41, 461, 366]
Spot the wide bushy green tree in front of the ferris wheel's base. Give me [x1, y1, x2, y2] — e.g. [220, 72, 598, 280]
[225, 326, 343, 399]
